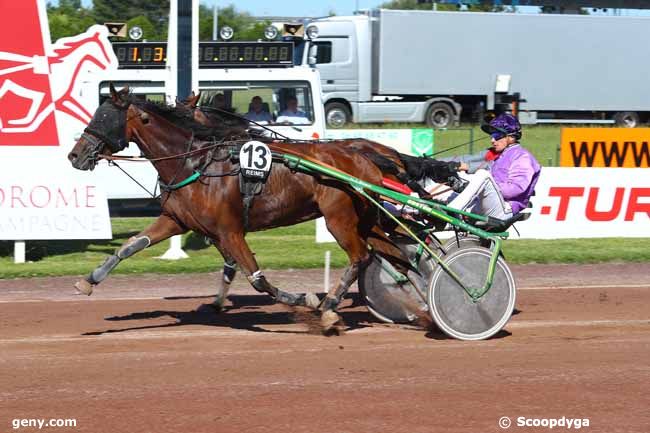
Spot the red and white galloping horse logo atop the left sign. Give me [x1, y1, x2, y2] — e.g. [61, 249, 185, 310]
[0, 0, 117, 145]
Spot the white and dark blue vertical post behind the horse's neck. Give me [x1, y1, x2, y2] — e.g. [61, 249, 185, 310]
[160, 0, 199, 260]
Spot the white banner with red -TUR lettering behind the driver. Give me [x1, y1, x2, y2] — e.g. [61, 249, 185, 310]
[316, 167, 650, 242]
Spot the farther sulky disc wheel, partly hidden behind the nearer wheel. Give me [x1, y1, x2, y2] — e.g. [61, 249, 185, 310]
[359, 239, 436, 323]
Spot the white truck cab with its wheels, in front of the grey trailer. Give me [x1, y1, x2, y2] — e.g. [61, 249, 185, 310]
[301, 15, 462, 128]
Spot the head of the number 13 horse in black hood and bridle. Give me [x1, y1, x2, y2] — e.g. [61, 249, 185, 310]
[68, 83, 133, 170]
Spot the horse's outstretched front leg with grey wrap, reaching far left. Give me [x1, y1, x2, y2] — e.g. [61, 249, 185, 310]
[74, 215, 187, 296]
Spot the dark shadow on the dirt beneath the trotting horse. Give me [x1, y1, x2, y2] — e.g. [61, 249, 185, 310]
[82, 295, 372, 336]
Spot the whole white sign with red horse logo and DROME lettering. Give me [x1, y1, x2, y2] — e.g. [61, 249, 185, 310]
[0, 14, 117, 240]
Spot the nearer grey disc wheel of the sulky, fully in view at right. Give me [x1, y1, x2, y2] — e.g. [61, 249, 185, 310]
[429, 247, 516, 340]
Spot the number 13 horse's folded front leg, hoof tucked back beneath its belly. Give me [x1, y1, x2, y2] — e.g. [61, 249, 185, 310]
[219, 232, 319, 308]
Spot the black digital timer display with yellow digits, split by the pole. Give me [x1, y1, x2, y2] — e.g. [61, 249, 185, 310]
[113, 42, 293, 69]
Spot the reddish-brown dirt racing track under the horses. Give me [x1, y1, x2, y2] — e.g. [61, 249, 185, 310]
[0, 264, 650, 433]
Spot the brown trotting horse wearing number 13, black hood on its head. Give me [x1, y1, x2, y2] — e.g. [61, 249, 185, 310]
[68, 86, 420, 331]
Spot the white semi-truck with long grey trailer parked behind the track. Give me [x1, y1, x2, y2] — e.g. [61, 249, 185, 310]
[302, 9, 650, 127]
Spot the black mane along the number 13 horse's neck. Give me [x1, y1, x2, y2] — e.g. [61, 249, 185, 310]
[128, 95, 245, 140]
